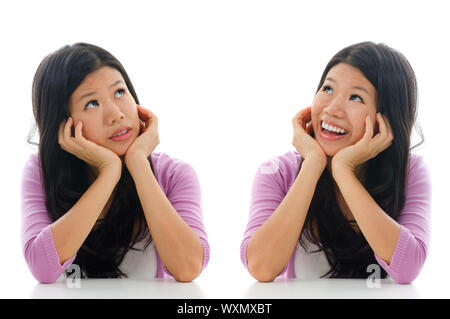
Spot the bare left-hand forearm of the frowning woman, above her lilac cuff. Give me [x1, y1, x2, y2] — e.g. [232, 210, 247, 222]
[50, 170, 120, 264]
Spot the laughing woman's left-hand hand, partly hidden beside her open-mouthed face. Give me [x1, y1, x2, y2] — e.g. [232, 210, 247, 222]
[292, 107, 327, 165]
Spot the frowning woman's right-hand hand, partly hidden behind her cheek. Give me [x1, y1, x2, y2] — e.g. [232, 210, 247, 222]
[125, 105, 159, 163]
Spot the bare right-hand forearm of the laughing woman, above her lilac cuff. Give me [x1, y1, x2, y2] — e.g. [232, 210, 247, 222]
[333, 167, 401, 264]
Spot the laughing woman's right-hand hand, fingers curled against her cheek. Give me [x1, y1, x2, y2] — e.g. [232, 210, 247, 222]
[332, 113, 394, 172]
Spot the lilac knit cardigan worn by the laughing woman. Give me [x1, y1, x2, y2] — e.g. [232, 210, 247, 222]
[240, 151, 431, 283]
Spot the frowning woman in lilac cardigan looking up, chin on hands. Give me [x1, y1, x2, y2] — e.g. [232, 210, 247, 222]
[22, 43, 209, 283]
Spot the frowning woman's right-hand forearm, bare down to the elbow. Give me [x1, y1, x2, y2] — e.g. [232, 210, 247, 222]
[127, 156, 203, 282]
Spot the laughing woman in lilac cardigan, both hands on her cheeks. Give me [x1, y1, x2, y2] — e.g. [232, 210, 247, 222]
[241, 42, 431, 283]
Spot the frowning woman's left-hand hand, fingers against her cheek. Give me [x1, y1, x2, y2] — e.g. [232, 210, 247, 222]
[58, 117, 122, 174]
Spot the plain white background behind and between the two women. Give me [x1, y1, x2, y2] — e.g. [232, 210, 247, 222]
[0, 0, 450, 297]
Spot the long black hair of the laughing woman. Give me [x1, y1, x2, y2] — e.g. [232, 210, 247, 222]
[299, 42, 424, 278]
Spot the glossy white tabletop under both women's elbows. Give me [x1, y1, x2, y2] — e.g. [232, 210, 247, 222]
[23, 278, 450, 299]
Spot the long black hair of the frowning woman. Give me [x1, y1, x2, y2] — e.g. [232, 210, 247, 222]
[28, 43, 153, 278]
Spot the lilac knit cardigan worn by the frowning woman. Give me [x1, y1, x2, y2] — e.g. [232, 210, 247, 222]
[22, 152, 210, 283]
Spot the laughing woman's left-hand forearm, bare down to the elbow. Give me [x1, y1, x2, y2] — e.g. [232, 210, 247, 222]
[247, 159, 323, 281]
